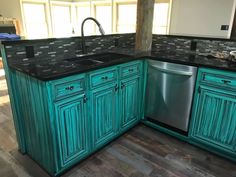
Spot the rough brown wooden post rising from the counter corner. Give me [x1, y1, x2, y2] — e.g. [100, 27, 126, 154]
[135, 0, 155, 52]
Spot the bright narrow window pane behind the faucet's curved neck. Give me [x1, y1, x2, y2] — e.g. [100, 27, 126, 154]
[75, 6, 93, 35]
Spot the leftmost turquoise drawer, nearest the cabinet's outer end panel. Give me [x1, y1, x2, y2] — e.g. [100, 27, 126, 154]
[52, 74, 85, 100]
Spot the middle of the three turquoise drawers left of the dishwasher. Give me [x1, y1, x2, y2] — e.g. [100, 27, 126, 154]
[90, 67, 117, 88]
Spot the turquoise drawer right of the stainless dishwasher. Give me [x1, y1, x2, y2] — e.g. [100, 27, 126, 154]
[201, 70, 236, 87]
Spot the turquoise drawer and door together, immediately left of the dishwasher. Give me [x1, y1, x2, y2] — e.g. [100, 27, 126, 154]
[119, 61, 143, 132]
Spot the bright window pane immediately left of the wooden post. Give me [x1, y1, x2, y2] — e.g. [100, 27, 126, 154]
[117, 4, 137, 33]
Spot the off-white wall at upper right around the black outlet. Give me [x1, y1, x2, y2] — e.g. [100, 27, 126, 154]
[170, 0, 234, 38]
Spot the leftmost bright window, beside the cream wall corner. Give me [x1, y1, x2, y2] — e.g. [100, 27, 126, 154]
[22, 2, 48, 39]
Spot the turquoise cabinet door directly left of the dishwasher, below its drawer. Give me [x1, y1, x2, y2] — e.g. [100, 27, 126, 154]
[120, 76, 143, 131]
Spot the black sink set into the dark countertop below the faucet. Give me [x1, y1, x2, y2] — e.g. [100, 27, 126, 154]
[66, 53, 130, 66]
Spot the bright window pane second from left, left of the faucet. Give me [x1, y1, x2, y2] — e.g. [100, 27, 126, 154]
[52, 5, 72, 37]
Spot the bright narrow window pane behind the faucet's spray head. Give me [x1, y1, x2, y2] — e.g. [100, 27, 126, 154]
[96, 5, 112, 34]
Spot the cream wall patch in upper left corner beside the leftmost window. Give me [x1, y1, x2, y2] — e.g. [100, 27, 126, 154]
[0, 0, 24, 34]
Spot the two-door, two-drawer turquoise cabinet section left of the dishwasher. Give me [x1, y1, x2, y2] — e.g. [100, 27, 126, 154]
[89, 61, 143, 149]
